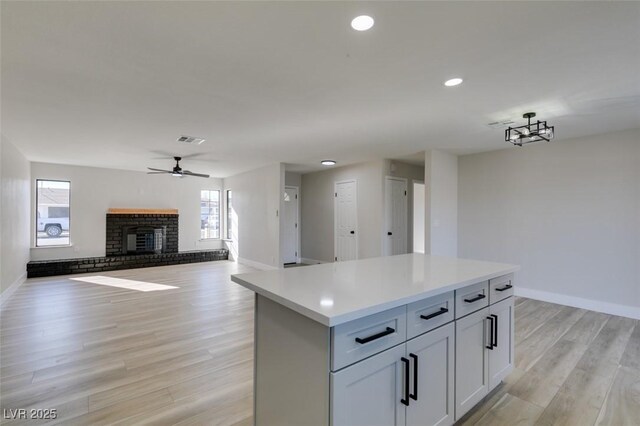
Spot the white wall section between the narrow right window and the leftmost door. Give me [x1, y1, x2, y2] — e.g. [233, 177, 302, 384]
[224, 164, 284, 268]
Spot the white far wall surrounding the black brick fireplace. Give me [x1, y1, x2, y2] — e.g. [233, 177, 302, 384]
[30, 163, 224, 260]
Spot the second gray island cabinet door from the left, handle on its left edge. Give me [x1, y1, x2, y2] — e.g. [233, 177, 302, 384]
[407, 323, 455, 426]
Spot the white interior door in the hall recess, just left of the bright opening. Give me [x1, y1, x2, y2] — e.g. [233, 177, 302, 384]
[383, 177, 407, 256]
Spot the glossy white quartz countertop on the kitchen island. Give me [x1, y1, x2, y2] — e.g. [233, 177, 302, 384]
[231, 254, 520, 327]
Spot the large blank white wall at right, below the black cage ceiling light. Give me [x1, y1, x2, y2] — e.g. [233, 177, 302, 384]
[459, 129, 640, 317]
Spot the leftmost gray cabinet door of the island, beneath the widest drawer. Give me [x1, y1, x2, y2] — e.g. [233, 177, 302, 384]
[331, 344, 408, 426]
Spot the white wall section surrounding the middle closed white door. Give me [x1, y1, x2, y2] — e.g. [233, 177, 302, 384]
[301, 160, 386, 262]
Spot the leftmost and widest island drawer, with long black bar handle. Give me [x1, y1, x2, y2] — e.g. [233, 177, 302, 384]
[331, 305, 407, 371]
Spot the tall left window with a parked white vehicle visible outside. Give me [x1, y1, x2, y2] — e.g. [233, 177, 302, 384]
[36, 179, 71, 247]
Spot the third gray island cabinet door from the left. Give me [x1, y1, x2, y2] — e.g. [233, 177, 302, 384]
[455, 308, 490, 420]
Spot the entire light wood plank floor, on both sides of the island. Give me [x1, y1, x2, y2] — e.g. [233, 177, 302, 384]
[0, 261, 640, 426]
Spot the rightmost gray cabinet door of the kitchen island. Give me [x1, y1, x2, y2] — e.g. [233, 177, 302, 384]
[489, 297, 515, 389]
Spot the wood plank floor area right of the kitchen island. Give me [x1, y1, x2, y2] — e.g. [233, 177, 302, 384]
[458, 298, 640, 426]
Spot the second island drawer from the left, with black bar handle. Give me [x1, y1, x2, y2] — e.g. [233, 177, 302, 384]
[407, 291, 454, 339]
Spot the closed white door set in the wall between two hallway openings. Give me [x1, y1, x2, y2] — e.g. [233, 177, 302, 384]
[334, 180, 358, 261]
